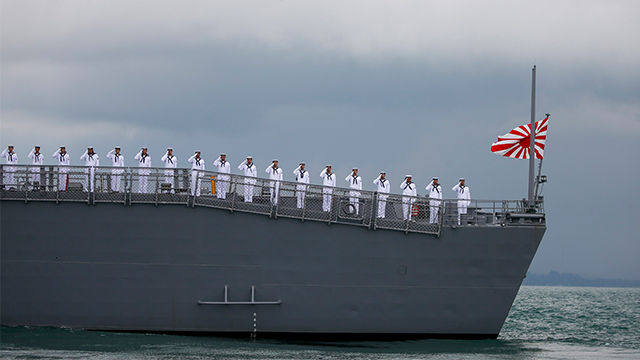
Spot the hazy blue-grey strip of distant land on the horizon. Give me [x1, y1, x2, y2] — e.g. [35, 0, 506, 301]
[522, 271, 640, 288]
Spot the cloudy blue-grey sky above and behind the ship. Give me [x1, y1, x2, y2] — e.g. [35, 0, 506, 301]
[0, 0, 640, 280]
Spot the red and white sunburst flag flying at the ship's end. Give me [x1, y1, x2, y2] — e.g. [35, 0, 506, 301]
[491, 116, 549, 159]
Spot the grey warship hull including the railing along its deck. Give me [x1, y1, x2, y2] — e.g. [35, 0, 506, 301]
[0, 166, 546, 340]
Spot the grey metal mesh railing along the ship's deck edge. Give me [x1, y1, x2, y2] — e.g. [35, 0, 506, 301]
[0, 165, 545, 235]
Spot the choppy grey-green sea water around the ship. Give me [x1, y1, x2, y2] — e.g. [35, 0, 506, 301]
[0, 286, 640, 360]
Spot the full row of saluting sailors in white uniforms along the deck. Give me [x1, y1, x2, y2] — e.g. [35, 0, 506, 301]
[0, 145, 471, 223]
